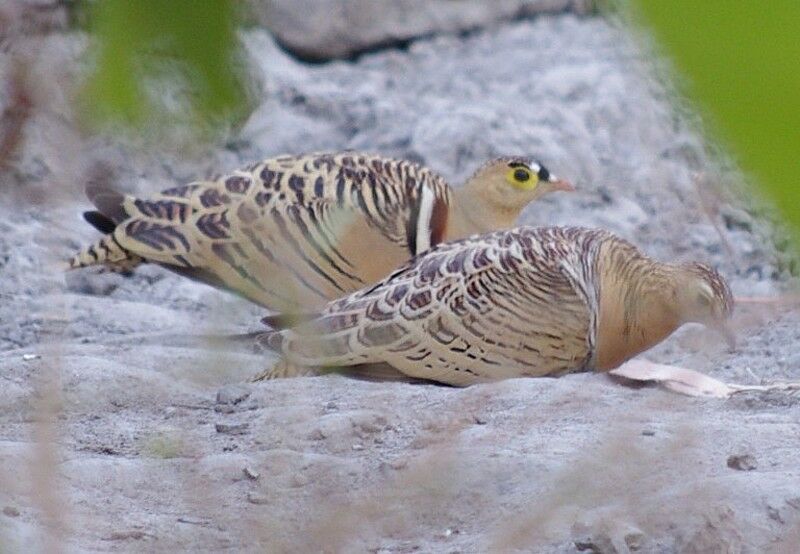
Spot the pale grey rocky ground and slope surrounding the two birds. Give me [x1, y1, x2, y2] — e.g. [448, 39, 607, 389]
[0, 0, 800, 552]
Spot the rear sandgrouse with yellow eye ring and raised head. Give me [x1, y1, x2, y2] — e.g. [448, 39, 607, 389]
[70, 153, 572, 312]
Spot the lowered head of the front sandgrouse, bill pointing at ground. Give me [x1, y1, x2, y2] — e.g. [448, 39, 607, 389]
[677, 262, 736, 349]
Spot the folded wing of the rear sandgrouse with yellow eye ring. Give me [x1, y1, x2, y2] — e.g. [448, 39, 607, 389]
[111, 193, 407, 311]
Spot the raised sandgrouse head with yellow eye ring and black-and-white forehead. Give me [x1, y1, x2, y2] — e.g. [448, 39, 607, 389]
[465, 157, 575, 213]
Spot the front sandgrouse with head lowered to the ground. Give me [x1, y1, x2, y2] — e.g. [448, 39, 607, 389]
[256, 227, 733, 385]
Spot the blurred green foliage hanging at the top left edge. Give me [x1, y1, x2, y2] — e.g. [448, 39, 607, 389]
[84, 0, 245, 132]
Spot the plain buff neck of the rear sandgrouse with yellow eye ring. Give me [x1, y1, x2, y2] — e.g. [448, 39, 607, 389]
[446, 183, 519, 240]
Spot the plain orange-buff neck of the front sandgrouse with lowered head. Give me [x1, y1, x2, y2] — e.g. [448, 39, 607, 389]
[595, 245, 683, 371]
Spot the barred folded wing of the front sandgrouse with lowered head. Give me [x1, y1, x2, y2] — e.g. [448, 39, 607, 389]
[283, 233, 588, 385]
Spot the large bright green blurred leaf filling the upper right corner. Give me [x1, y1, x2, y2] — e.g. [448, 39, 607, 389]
[633, 0, 800, 245]
